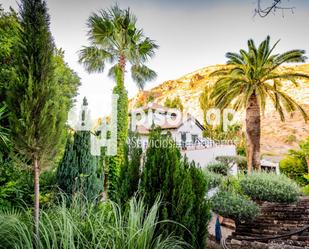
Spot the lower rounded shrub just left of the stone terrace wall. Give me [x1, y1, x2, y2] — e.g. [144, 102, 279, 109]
[211, 191, 260, 224]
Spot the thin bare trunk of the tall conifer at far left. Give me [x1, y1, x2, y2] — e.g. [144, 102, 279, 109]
[33, 157, 40, 240]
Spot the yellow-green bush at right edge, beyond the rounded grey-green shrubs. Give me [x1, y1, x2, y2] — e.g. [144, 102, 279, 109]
[279, 155, 308, 185]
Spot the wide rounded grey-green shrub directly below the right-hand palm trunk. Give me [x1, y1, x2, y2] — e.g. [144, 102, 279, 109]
[240, 172, 300, 203]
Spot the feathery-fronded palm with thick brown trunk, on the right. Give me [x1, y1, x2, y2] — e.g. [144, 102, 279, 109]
[211, 36, 309, 172]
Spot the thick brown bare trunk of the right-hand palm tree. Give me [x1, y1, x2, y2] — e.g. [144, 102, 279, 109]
[246, 93, 261, 174]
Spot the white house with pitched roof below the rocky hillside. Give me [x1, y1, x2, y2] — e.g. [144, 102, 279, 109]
[129, 103, 237, 168]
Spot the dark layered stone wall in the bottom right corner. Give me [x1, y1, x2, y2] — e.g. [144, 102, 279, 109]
[226, 197, 309, 249]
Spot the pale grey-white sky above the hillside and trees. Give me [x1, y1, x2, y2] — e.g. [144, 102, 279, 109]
[0, 0, 309, 118]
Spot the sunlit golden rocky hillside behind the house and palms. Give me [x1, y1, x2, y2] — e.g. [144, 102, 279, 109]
[130, 64, 309, 155]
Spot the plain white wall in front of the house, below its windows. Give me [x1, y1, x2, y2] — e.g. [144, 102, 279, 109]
[182, 145, 236, 168]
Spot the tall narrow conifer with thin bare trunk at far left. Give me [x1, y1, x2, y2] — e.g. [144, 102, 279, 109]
[7, 0, 66, 235]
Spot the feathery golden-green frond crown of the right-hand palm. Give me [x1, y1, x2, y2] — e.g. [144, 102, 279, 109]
[211, 36, 309, 120]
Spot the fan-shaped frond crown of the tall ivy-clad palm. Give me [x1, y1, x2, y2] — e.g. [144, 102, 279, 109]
[80, 5, 158, 89]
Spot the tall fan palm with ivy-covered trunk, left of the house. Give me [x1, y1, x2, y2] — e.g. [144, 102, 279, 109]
[80, 5, 158, 198]
